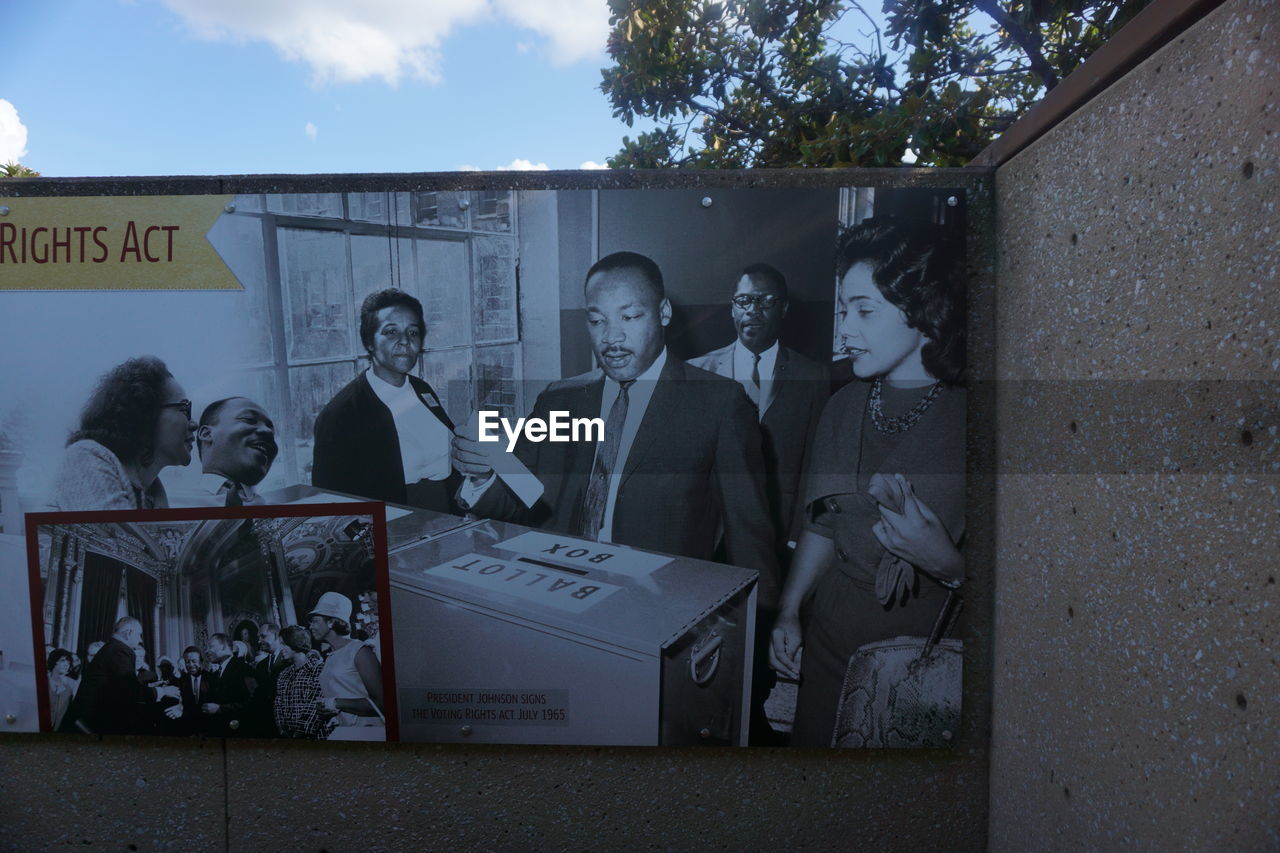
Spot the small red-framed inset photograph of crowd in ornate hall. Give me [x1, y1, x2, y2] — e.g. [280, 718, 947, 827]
[28, 505, 393, 740]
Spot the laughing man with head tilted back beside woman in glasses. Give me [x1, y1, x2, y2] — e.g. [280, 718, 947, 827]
[169, 397, 279, 506]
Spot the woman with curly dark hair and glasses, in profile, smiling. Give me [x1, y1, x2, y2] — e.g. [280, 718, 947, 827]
[49, 356, 196, 512]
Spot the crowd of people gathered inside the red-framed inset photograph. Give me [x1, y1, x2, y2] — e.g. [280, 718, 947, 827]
[46, 592, 385, 740]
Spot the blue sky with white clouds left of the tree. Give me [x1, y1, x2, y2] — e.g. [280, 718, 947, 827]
[0, 0, 670, 177]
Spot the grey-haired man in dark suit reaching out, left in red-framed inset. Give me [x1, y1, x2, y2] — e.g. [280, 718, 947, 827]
[63, 616, 178, 734]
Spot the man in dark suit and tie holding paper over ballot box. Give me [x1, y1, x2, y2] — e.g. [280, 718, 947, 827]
[453, 252, 778, 610]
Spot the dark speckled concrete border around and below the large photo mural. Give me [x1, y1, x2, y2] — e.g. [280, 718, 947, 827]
[0, 169, 995, 852]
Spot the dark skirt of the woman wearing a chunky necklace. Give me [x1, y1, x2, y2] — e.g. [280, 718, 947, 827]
[791, 569, 947, 747]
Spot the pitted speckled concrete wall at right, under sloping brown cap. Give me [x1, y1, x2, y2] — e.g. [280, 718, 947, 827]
[991, 0, 1280, 850]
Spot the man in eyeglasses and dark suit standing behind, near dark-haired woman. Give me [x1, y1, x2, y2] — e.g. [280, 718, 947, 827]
[689, 264, 831, 567]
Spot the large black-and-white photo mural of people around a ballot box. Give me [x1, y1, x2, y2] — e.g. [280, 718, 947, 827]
[0, 187, 965, 748]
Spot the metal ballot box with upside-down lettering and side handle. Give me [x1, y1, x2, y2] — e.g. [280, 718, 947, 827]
[388, 514, 756, 745]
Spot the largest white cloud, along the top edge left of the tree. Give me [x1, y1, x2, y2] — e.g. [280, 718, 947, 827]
[164, 0, 608, 86]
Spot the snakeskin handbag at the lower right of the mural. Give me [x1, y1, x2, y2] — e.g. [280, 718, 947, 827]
[831, 590, 964, 749]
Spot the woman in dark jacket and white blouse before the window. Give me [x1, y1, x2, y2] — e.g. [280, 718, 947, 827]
[311, 288, 461, 514]
